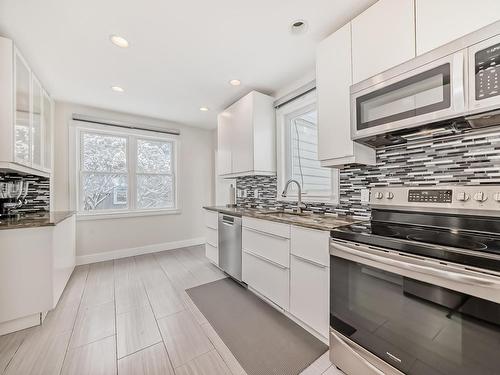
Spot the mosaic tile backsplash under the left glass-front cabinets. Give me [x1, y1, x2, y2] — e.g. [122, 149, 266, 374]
[0, 173, 50, 213]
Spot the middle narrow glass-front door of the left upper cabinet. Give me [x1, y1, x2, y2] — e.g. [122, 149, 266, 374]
[31, 75, 44, 169]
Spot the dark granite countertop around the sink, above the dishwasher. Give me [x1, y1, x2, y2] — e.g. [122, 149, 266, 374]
[203, 206, 360, 231]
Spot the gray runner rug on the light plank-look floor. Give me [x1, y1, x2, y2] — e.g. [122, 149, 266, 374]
[186, 278, 328, 375]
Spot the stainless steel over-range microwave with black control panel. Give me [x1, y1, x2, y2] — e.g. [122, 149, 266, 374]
[350, 21, 500, 144]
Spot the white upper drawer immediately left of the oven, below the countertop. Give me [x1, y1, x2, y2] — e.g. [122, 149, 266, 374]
[290, 226, 330, 266]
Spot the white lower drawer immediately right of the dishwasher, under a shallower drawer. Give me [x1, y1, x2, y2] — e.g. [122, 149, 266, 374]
[242, 251, 289, 310]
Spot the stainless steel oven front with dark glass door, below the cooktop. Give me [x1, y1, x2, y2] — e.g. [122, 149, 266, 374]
[330, 241, 500, 375]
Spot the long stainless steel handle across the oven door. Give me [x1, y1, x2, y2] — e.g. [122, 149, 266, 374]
[332, 242, 500, 289]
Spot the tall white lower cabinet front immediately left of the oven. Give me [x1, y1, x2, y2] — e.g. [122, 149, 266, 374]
[290, 255, 330, 338]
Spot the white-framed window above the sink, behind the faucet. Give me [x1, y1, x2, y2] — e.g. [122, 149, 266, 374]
[276, 91, 338, 204]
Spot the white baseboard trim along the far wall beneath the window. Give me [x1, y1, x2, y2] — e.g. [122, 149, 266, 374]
[76, 237, 205, 265]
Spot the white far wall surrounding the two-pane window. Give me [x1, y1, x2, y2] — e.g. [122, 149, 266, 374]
[54, 102, 215, 259]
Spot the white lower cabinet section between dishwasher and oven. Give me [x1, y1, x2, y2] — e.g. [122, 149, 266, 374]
[242, 217, 330, 341]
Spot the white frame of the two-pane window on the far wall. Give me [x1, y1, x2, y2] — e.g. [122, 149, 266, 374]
[69, 120, 181, 220]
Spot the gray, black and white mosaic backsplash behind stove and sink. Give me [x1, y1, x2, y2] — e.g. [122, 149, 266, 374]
[236, 128, 500, 219]
